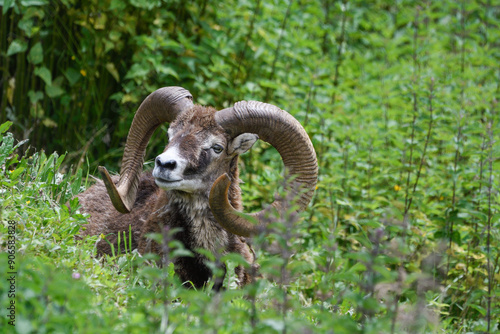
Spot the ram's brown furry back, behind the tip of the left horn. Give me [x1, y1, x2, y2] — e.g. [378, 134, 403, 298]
[77, 172, 158, 255]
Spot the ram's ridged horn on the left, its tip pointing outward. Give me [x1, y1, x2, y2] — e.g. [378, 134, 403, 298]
[99, 87, 193, 213]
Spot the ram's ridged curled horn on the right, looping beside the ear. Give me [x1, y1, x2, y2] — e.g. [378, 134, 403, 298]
[210, 101, 318, 236]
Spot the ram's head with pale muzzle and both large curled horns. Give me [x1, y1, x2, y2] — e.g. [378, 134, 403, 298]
[99, 87, 318, 236]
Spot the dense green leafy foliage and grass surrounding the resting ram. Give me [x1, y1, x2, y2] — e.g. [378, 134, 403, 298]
[0, 0, 500, 333]
